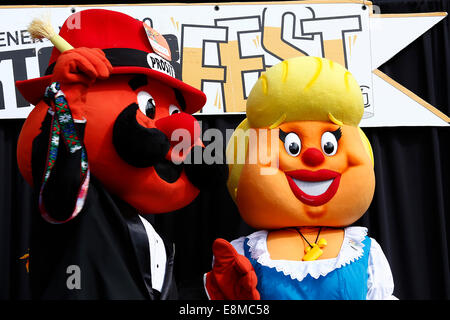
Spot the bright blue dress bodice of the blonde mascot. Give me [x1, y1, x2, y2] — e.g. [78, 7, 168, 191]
[244, 231, 371, 300]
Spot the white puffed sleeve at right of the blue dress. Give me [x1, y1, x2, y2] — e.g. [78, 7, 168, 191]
[366, 239, 397, 300]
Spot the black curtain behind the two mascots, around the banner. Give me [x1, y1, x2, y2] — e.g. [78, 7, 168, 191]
[0, 0, 450, 299]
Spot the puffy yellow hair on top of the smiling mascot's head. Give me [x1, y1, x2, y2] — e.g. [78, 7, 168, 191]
[246, 56, 364, 128]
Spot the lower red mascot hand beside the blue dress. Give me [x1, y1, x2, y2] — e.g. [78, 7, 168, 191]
[205, 239, 260, 300]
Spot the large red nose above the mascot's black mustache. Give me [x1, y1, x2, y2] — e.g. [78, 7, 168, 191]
[155, 112, 201, 146]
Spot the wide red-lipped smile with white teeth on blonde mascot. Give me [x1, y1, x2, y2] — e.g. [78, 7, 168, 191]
[286, 169, 341, 206]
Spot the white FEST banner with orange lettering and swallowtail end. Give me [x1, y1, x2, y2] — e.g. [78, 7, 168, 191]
[0, 0, 450, 127]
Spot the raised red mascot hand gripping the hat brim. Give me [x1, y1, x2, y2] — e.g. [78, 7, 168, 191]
[52, 47, 112, 120]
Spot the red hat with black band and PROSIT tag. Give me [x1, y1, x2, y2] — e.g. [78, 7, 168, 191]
[16, 9, 206, 114]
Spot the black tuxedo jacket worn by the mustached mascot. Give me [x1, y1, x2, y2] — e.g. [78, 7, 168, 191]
[29, 115, 177, 300]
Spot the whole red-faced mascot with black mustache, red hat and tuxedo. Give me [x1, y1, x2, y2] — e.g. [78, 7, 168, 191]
[17, 10, 226, 299]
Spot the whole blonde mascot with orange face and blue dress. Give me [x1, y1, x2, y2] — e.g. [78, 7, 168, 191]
[205, 57, 395, 300]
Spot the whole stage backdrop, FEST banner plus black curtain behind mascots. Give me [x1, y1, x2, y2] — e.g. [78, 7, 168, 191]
[0, 0, 450, 299]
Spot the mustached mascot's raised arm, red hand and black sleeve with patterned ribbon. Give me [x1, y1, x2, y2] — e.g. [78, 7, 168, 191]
[32, 48, 112, 223]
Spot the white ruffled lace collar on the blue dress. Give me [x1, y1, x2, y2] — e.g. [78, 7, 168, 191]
[247, 227, 367, 281]
